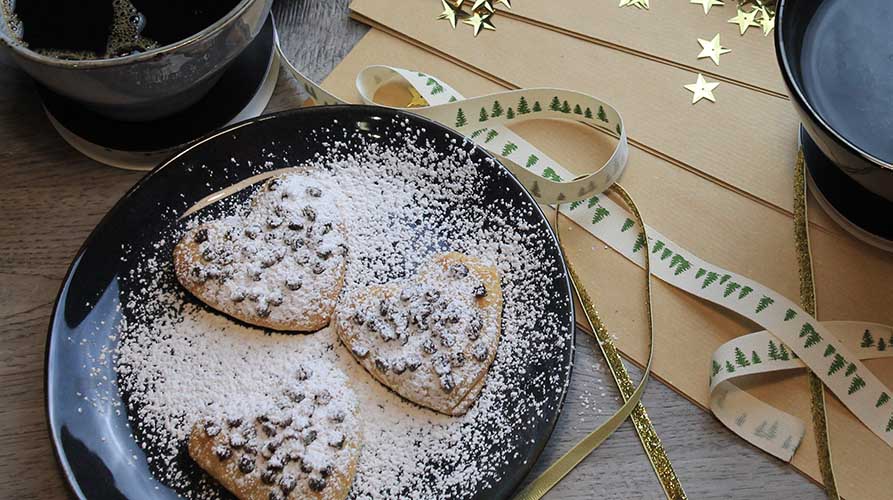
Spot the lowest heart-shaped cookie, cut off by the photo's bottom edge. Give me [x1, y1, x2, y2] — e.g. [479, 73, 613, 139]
[189, 368, 362, 500]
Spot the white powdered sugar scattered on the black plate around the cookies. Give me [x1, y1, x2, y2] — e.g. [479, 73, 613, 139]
[97, 114, 572, 498]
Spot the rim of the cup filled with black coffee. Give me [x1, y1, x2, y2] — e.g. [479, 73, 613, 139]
[0, 0, 269, 69]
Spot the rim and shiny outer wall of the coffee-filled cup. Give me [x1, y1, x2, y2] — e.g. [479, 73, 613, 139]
[0, 0, 273, 121]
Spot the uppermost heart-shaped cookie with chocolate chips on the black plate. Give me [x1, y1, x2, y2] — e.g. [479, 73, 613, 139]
[174, 174, 347, 331]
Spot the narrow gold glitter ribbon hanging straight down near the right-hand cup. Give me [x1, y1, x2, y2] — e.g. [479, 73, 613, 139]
[794, 149, 840, 499]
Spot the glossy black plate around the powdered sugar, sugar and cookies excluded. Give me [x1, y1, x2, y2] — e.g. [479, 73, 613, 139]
[46, 106, 574, 499]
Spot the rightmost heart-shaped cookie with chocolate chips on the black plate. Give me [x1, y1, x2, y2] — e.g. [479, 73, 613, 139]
[335, 252, 502, 415]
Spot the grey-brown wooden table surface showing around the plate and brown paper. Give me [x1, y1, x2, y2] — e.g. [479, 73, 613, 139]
[0, 0, 823, 500]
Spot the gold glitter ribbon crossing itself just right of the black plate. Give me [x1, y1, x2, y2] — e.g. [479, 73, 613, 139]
[515, 184, 686, 500]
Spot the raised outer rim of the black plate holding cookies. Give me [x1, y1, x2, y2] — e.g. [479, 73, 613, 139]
[43, 104, 577, 499]
